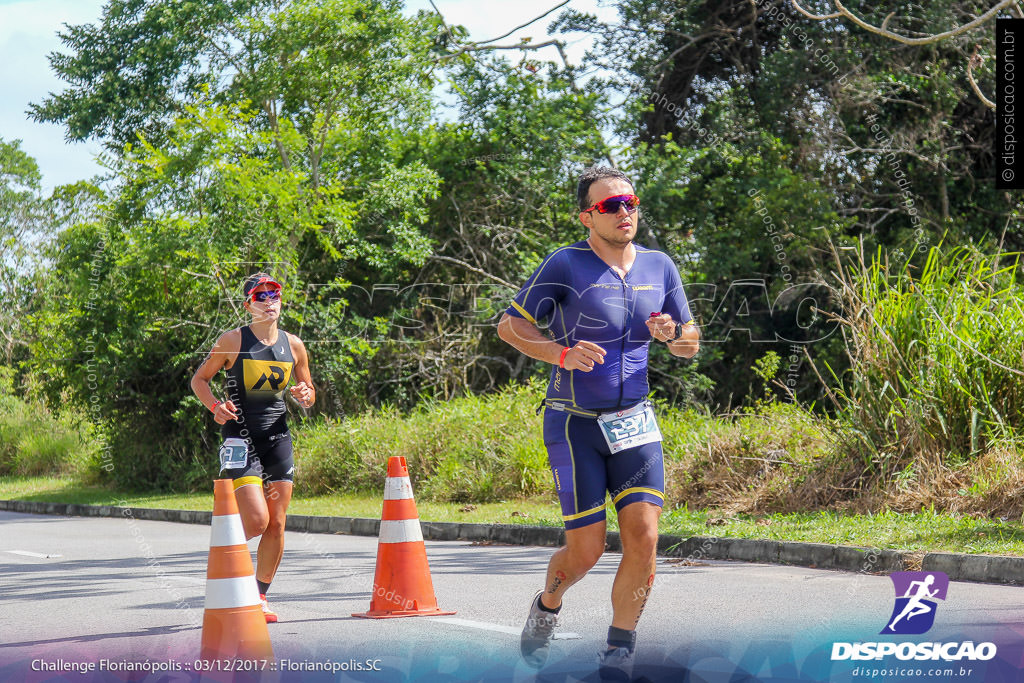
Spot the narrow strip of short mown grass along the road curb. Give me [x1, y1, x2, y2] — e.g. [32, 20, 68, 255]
[8, 476, 1024, 556]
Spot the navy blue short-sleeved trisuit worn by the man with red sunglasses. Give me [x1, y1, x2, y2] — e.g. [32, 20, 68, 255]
[506, 242, 693, 528]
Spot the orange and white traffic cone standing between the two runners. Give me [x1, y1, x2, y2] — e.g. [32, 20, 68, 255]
[352, 456, 455, 618]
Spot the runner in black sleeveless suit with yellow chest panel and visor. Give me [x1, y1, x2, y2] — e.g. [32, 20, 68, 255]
[191, 272, 316, 624]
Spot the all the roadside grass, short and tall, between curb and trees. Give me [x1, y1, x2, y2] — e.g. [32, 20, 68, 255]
[9, 247, 1024, 552]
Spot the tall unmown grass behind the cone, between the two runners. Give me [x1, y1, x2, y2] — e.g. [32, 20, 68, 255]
[296, 383, 551, 502]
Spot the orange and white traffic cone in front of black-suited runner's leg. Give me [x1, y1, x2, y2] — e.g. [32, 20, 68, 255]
[200, 479, 273, 660]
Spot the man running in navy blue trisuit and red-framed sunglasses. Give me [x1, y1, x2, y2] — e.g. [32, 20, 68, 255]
[498, 167, 699, 675]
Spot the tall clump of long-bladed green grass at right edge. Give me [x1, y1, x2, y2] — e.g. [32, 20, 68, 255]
[834, 245, 1024, 488]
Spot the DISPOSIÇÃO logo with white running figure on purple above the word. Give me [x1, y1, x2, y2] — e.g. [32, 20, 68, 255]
[831, 571, 995, 661]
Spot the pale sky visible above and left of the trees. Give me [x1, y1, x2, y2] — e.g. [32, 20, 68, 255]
[0, 0, 616, 191]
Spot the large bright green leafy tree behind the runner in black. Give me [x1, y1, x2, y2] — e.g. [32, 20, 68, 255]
[29, 0, 446, 487]
